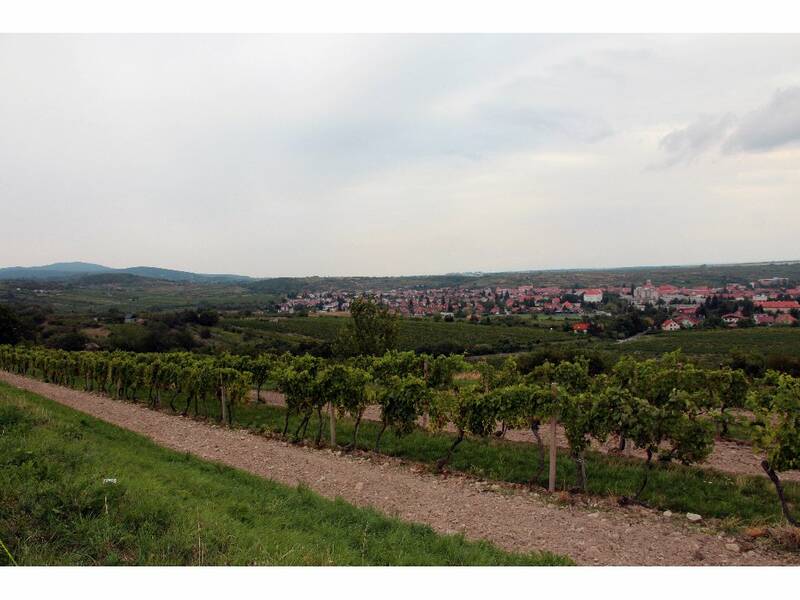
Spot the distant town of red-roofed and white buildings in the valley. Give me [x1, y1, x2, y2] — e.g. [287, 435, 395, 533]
[278, 277, 800, 333]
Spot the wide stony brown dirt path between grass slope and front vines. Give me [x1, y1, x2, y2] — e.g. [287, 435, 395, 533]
[0, 371, 800, 565]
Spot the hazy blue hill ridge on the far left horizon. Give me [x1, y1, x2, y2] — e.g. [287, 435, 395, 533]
[0, 262, 251, 283]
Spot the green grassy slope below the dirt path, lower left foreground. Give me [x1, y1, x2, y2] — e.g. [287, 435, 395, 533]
[0, 384, 570, 565]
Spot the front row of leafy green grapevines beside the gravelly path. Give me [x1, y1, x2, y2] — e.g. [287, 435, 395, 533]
[0, 346, 800, 522]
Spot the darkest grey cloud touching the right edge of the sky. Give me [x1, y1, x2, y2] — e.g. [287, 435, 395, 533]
[724, 87, 800, 152]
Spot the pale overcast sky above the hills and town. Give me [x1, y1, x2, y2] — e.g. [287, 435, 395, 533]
[0, 34, 800, 277]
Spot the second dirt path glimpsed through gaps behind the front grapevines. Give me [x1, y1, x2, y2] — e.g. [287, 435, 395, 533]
[250, 391, 800, 481]
